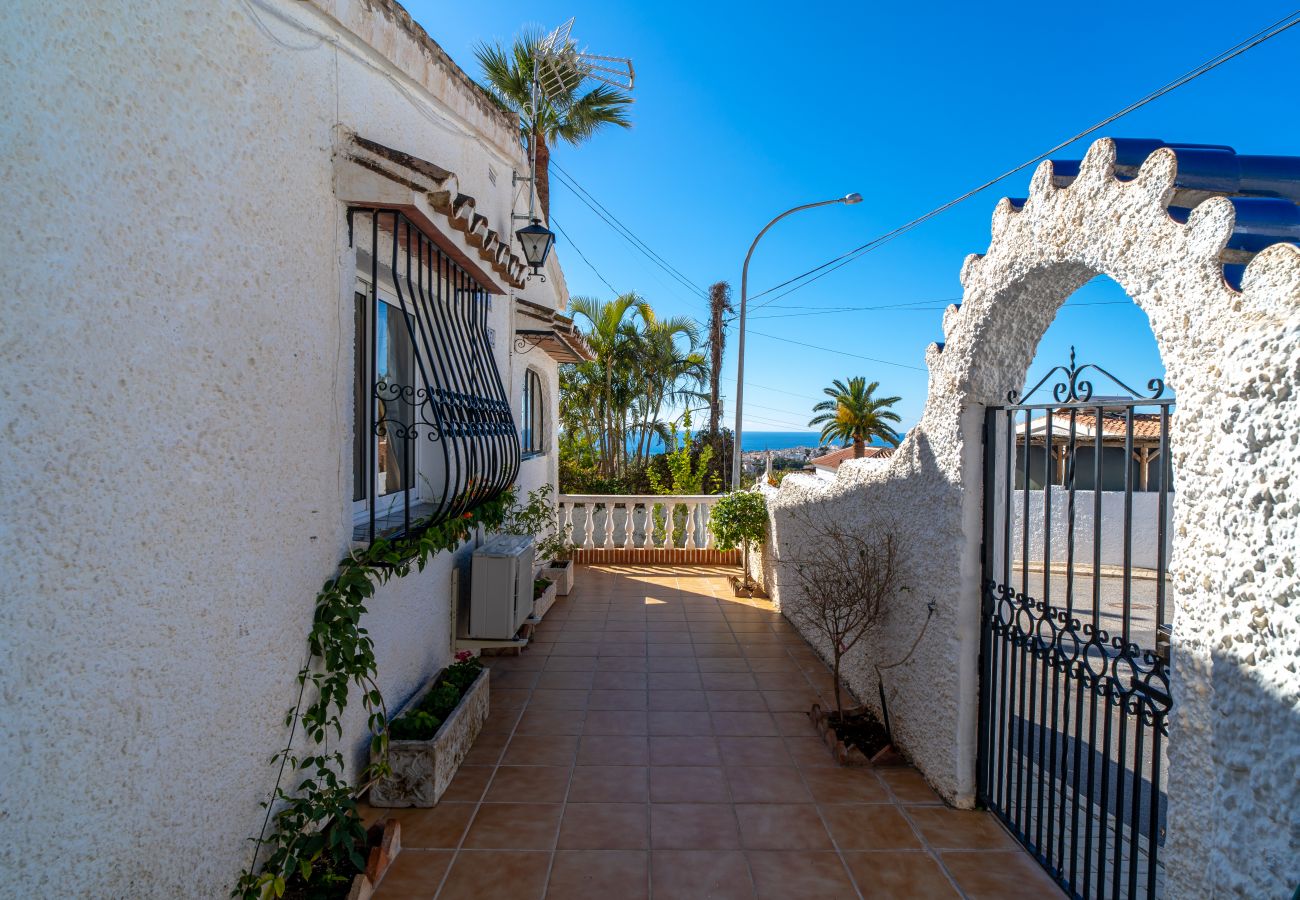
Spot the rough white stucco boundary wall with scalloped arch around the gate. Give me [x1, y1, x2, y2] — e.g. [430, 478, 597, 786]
[764, 140, 1300, 897]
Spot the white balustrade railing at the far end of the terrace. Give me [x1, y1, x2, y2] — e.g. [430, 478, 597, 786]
[556, 494, 719, 550]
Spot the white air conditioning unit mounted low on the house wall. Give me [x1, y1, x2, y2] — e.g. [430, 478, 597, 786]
[469, 535, 533, 641]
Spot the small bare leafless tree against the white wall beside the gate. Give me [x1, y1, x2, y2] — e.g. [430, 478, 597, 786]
[788, 512, 902, 722]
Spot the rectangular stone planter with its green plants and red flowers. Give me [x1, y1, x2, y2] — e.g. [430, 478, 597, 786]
[371, 650, 489, 808]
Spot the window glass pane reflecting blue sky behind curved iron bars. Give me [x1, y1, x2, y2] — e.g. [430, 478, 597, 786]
[374, 303, 415, 497]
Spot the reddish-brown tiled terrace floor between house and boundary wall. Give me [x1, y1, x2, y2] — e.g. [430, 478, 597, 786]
[364, 566, 1061, 900]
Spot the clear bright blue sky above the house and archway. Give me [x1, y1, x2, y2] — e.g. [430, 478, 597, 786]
[406, 0, 1300, 430]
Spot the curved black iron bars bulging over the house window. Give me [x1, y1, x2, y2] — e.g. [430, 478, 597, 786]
[348, 207, 520, 541]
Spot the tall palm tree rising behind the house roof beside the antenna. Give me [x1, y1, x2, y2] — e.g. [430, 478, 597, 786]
[475, 31, 632, 221]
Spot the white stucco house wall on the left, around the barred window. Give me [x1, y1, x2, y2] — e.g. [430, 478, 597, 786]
[0, 0, 563, 897]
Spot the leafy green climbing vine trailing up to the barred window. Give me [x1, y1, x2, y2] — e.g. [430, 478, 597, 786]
[230, 490, 515, 900]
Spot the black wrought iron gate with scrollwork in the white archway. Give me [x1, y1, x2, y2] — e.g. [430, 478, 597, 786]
[979, 349, 1174, 899]
